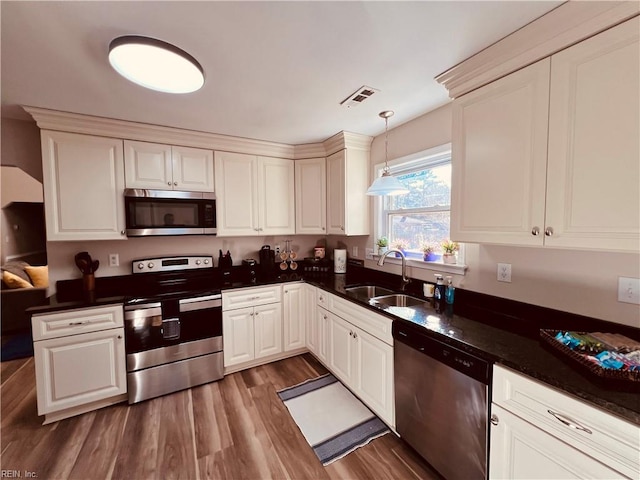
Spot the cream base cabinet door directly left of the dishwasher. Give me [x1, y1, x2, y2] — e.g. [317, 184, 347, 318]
[354, 329, 395, 426]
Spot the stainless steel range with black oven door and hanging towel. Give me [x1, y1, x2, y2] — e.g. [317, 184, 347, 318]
[124, 255, 223, 404]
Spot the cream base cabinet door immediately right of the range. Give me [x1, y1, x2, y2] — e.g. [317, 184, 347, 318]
[222, 307, 255, 367]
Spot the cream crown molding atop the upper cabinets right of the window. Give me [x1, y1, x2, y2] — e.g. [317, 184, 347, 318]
[435, 1, 640, 98]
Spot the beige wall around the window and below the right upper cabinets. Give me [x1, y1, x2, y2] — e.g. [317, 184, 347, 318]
[364, 103, 640, 327]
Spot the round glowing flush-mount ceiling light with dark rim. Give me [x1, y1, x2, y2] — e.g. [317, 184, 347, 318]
[109, 35, 204, 93]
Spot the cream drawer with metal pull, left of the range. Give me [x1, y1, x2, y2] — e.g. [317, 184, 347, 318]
[31, 304, 124, 341]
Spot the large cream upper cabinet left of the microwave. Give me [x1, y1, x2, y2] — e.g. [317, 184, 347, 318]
[41, 130, 127, 241]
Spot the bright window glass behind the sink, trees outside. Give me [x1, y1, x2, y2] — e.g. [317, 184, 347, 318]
[377, 145, 460, 261]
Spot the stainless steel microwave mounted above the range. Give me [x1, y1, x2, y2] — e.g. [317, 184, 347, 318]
[124, 188, 217, 237]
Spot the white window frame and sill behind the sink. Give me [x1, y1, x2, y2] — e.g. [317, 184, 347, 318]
[373, 143, 467, 275]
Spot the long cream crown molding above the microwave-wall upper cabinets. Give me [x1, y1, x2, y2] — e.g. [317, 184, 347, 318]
[22, 106, 295, 159]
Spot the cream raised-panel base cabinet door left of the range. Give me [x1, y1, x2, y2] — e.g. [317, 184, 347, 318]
[34, 328, 127, 415]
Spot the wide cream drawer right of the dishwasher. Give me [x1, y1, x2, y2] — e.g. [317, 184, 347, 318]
[493, 365, 640, 478]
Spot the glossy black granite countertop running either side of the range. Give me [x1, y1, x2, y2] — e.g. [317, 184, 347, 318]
[28, 268, 640, 425]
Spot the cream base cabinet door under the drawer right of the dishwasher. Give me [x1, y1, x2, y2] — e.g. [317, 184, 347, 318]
[489, 403, 622, 480]
